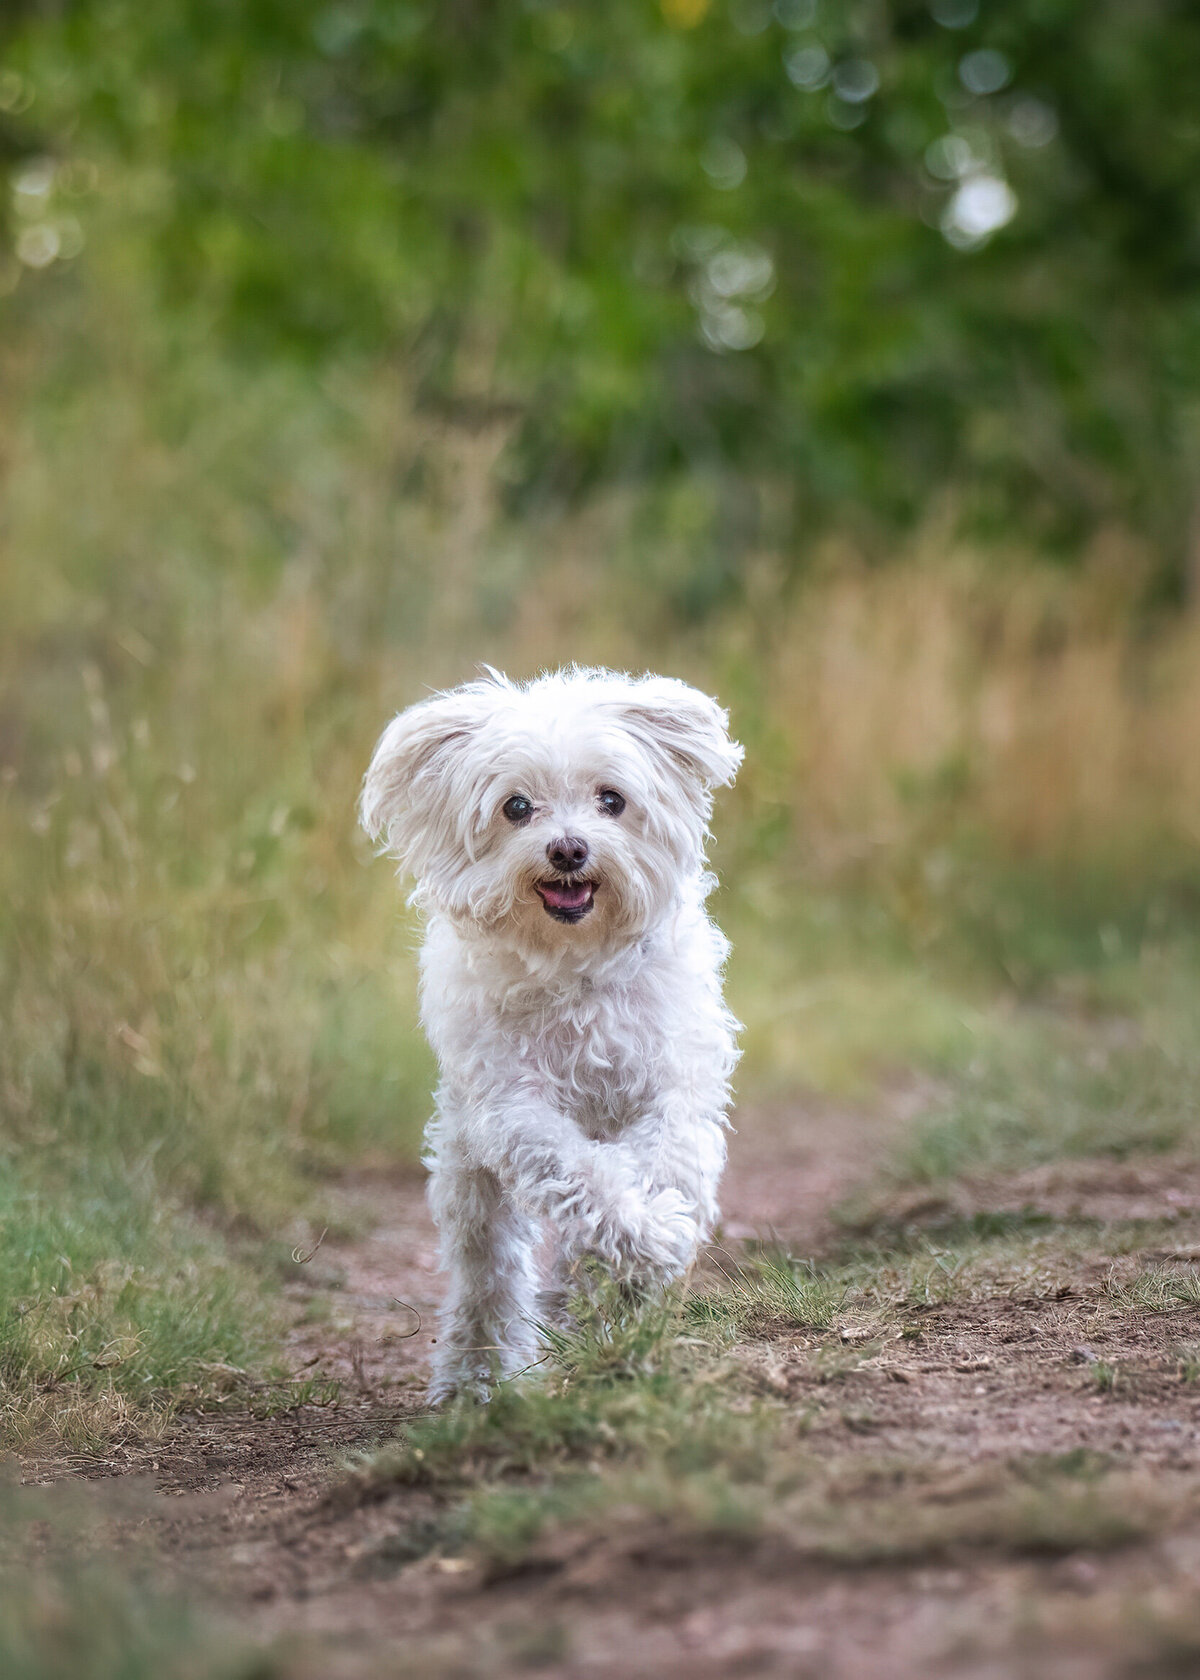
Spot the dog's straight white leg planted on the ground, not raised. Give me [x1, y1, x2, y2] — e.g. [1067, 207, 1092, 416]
[429, 1159, 538, 1404]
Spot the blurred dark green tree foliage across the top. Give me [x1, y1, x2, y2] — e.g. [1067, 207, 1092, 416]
[0, 0, 1200, 588]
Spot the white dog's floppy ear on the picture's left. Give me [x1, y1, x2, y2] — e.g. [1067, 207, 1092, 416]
[358, 674, 504, 875]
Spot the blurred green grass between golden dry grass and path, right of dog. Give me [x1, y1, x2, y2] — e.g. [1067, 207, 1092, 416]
[716, 853, 1200, 1102]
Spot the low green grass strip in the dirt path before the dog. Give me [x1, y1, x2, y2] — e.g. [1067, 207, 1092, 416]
[345, 1196, 1195, 1572]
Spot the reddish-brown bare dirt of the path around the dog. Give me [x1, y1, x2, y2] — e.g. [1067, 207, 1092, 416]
[18, 1100, 1200, 1680]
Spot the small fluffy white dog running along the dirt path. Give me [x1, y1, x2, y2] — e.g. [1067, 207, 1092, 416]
[361, 669, 741, 1401]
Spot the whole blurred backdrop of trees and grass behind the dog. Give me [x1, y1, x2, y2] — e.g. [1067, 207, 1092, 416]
[0, 0, 1200, 1433]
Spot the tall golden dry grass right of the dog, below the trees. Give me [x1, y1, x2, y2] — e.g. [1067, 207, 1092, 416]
[770, 558, 1200, 857]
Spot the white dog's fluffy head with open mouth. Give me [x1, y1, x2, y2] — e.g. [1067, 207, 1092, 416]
[361, 669, 741, 949]
